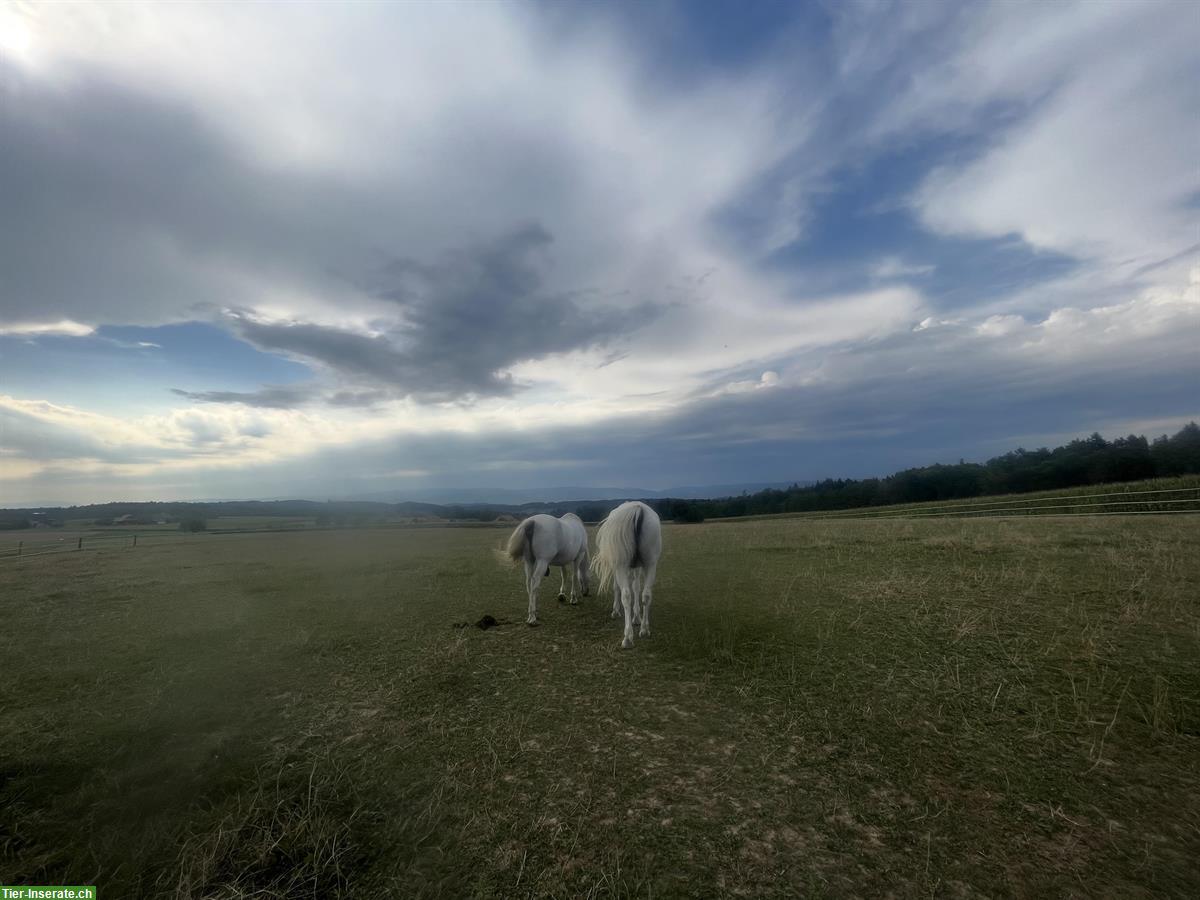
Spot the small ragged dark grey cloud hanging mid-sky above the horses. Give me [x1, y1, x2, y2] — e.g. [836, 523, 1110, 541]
[232, 224, 654, 401]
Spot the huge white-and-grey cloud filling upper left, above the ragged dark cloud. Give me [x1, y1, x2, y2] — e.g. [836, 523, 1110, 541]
[0, 5, 775, 328]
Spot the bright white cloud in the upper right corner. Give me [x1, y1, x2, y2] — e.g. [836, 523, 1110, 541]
[910, 2, 1200, 274]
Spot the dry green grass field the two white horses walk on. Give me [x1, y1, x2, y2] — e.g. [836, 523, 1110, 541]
[0, 516, 1200, 898]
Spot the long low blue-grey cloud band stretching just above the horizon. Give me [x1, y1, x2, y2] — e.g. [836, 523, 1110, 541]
[10, 289, 1200, 511]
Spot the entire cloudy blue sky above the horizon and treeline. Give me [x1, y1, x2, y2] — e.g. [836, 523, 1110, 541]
[0, 0, 1200, 506]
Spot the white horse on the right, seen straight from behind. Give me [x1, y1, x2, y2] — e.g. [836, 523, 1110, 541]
[595, 500, 662, 649]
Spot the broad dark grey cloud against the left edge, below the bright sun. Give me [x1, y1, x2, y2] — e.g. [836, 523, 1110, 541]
[0, 64, 319, 323]
